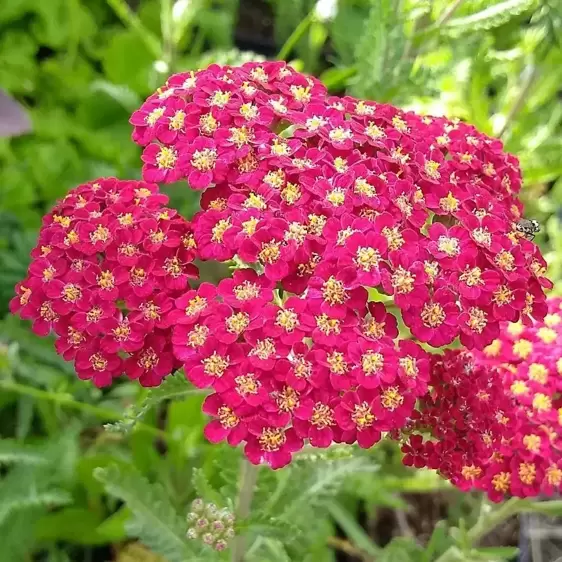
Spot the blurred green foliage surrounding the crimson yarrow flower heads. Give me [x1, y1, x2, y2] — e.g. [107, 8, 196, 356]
[0, 0, 562, 562]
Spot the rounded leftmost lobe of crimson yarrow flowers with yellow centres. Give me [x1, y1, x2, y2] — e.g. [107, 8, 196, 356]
[10, 178, 197, 386]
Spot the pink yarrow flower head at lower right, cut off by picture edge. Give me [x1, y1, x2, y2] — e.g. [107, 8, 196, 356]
[403, 299, 562, 501]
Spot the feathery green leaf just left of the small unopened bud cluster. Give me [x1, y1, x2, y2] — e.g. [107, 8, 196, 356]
[94, 466, 199, 562]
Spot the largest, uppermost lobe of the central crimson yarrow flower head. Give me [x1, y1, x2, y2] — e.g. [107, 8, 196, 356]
[131, 62, 550, 348]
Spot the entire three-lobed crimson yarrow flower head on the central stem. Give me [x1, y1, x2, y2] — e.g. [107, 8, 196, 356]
[13, 62, 550, 468]
